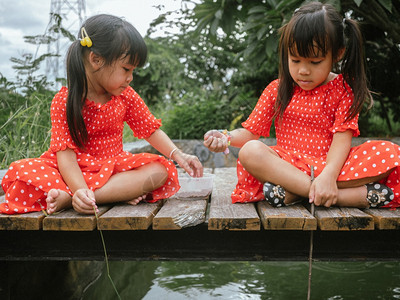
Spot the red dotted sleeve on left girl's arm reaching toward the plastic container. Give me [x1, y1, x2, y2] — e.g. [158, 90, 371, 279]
[121, 87, 161, 139]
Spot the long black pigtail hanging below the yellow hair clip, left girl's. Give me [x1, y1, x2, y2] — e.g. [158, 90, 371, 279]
[67, 40, 87, 148]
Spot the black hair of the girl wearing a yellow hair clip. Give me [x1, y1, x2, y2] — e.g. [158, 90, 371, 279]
[66, 14, 147, 148]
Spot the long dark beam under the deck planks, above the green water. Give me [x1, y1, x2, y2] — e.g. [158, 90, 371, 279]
[0, 229, 400, 261]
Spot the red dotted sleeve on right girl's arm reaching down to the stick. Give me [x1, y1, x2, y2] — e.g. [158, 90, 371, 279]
[329, 80, 360, 137]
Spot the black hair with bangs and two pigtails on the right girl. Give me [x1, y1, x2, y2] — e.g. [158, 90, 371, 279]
[275, 2, 372, 120]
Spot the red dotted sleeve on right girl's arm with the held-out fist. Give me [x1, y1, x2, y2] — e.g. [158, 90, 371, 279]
[242, 80, 279, 137]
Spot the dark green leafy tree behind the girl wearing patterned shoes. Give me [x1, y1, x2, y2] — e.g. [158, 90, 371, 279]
[183, 0, 400, 135]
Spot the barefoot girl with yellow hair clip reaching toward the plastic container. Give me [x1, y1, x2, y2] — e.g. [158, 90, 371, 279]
[0, 15, 203, 214]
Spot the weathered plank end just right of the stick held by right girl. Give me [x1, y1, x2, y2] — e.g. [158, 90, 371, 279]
[315, 207, 374, 231]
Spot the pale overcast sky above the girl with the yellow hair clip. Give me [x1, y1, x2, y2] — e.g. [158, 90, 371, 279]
[0, 0, 181, 80]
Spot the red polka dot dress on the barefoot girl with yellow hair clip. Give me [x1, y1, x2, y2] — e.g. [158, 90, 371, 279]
[0, 87, 179, 214]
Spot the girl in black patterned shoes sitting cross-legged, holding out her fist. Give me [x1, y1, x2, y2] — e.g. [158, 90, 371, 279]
[204, 2, 400, 208]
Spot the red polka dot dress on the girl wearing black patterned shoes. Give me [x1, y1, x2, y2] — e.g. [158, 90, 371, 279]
[232, 74, 400, 207]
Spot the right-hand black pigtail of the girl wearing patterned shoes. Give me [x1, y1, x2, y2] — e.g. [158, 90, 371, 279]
[341, 19, 373, 119]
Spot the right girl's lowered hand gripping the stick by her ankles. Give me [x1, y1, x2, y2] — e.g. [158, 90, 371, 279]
[309, 172, 339, 207]
